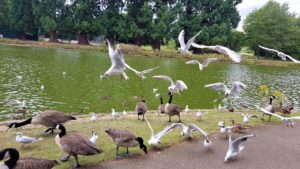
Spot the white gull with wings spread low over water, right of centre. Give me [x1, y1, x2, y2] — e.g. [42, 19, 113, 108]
[205, 81, 247, 96]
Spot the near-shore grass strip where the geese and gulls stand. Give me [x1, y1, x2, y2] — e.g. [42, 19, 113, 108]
[0, 110, 294, 169]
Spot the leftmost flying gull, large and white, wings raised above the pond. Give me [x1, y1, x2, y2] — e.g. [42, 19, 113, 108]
[100, 39, 129, 80]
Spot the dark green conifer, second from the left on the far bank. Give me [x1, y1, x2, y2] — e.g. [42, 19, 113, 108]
[33, 0, 65, 42]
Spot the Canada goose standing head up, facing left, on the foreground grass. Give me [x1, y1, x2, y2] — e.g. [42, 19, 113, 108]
[55, 124, 103, 167]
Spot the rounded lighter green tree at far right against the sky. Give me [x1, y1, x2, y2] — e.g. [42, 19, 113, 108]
[244, 1, 300, 58]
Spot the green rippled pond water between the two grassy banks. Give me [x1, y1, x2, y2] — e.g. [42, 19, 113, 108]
[0, 45, 300, 116]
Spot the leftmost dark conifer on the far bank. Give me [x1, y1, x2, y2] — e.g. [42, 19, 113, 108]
[10, 0, 37, 39]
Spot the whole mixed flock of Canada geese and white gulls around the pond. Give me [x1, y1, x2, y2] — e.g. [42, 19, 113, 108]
[0, 30, 300, 169]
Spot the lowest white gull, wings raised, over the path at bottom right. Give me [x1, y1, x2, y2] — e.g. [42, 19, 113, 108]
[224, 134, 255, 163]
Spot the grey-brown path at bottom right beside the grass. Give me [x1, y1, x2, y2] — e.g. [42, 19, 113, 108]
[86, 123, 300, 169]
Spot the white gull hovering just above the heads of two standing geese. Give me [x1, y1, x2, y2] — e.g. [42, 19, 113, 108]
[153, 75, 187, 94]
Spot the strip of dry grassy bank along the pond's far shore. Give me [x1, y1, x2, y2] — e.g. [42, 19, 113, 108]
[0, 38, 298, 66]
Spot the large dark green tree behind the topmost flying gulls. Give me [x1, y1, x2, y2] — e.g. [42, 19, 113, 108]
[173, 0, 242, 53]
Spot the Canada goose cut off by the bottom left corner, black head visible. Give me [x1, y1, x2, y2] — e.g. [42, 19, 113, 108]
[0, 148, 58, 169]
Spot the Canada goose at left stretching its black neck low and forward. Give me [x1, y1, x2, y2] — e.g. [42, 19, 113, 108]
[8, 110, 76, 133]
